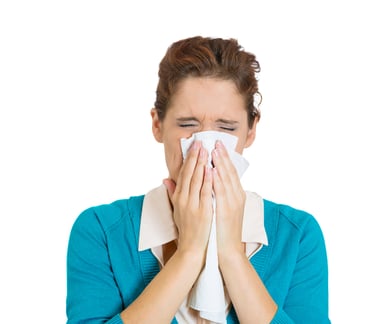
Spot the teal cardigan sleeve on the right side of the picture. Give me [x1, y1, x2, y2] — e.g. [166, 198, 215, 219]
[271, 214, 330, 324]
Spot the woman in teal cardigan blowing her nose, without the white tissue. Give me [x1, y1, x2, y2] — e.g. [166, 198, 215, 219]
[67, 37, 330, 324]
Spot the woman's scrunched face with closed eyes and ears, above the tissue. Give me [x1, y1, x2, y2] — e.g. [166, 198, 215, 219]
[151, 78, 256, 181]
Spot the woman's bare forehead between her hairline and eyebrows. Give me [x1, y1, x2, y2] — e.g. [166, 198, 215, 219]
[168, 77, 246, 117]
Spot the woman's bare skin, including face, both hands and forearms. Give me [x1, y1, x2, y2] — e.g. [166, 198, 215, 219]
[121, 78, 277, 324]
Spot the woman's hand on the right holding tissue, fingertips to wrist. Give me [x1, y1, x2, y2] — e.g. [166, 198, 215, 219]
[212, 141, 246, 257]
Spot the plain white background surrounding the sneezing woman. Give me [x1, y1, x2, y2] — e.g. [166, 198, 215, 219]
[0, 0, 388, 323]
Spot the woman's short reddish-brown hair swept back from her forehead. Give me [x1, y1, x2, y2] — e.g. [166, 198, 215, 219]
[155, 36, 261, 128]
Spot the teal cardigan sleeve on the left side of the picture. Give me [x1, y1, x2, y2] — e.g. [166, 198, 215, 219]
[66, 208, 123, 324]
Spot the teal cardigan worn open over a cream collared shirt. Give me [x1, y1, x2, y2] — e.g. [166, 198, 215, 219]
[66, 196, 330, 324]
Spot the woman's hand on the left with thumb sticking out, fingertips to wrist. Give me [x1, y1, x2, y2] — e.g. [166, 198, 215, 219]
[163, 141, 213, 256]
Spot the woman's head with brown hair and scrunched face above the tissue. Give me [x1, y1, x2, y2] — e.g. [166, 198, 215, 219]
[151, 37, 261, 180]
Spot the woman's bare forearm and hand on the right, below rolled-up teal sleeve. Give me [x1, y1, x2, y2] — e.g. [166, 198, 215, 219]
[213, 142, 277, 324]
